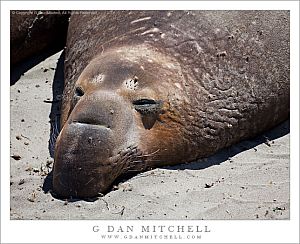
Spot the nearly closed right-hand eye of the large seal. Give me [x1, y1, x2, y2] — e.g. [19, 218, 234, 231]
[133, 99, 162, 115]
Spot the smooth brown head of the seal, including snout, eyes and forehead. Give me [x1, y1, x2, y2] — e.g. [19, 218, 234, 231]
[53, 45, 184, 197]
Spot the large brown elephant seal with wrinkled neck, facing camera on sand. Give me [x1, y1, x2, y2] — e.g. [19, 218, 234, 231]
[53, 11, 290, 198]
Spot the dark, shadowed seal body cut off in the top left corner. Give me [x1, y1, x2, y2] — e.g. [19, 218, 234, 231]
[10, 10, 70, 65]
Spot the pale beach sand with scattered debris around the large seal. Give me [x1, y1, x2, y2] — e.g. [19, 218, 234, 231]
[10, 52, 290, 220]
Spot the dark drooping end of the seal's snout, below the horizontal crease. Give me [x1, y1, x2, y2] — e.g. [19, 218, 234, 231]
[53, 123, 114, 197]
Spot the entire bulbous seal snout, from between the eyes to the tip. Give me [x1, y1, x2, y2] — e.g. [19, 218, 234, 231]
[53, 92, 137, 198]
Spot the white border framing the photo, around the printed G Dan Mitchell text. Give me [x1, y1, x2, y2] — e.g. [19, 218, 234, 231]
[1, 1, 299, 243]
